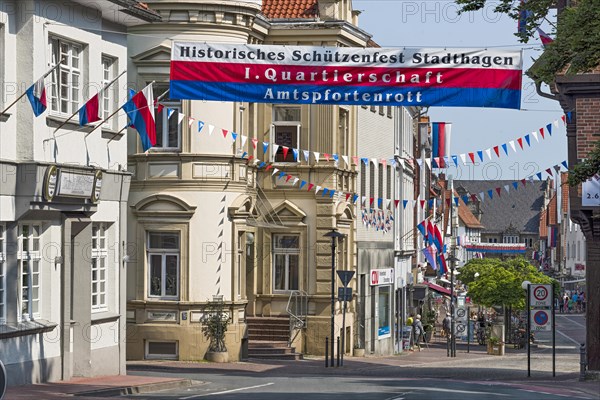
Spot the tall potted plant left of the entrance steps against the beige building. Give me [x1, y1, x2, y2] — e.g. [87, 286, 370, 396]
[201, 296, 229, 362]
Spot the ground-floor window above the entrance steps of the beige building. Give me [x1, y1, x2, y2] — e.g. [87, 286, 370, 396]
[273, 235, 300, 291]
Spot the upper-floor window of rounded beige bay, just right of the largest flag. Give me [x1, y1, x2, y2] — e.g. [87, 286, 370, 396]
[152, 88, 183, 151]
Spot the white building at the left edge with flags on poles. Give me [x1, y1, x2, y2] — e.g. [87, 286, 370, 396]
[0, 0, 157, 385]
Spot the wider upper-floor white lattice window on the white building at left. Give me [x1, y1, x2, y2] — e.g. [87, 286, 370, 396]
[50, 38, 81, 115]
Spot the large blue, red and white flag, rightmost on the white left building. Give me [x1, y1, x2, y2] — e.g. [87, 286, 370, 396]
[123, 84, 156, 151]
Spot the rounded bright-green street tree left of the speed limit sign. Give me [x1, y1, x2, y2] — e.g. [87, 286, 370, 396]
[459, 258, 553, 309]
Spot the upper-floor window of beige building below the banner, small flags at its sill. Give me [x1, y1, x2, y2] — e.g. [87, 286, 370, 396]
[271, 107, 301, 162]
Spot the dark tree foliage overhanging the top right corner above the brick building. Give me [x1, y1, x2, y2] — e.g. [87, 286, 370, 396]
[455, 0, 600, 85]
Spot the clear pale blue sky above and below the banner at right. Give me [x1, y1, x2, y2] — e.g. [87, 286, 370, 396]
[352, 0, 567, 180]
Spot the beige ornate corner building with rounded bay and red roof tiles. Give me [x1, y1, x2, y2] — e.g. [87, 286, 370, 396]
[127, 0, 370, 360]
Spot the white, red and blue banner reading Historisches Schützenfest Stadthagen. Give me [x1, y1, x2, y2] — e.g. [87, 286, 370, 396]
[169, 42, 522, 109]
